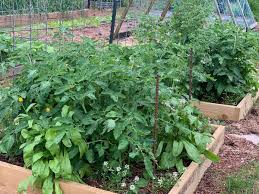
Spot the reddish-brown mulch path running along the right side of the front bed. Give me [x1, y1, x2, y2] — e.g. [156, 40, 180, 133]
[195, 104, 259, 194]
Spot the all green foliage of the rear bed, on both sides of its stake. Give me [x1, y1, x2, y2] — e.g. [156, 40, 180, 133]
[136, 9, 259, 104]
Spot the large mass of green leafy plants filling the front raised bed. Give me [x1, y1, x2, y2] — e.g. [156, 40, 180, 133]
[0, 40, 218, 194]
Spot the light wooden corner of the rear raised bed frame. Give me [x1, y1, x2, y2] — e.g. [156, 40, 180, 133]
[193, 91, 259, 121]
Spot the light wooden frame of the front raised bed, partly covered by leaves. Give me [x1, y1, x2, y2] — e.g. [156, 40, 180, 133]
[0, 126, 225, 194]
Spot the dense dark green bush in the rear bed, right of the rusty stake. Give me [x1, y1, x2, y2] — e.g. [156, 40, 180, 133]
[192, 23, 258, 104]
